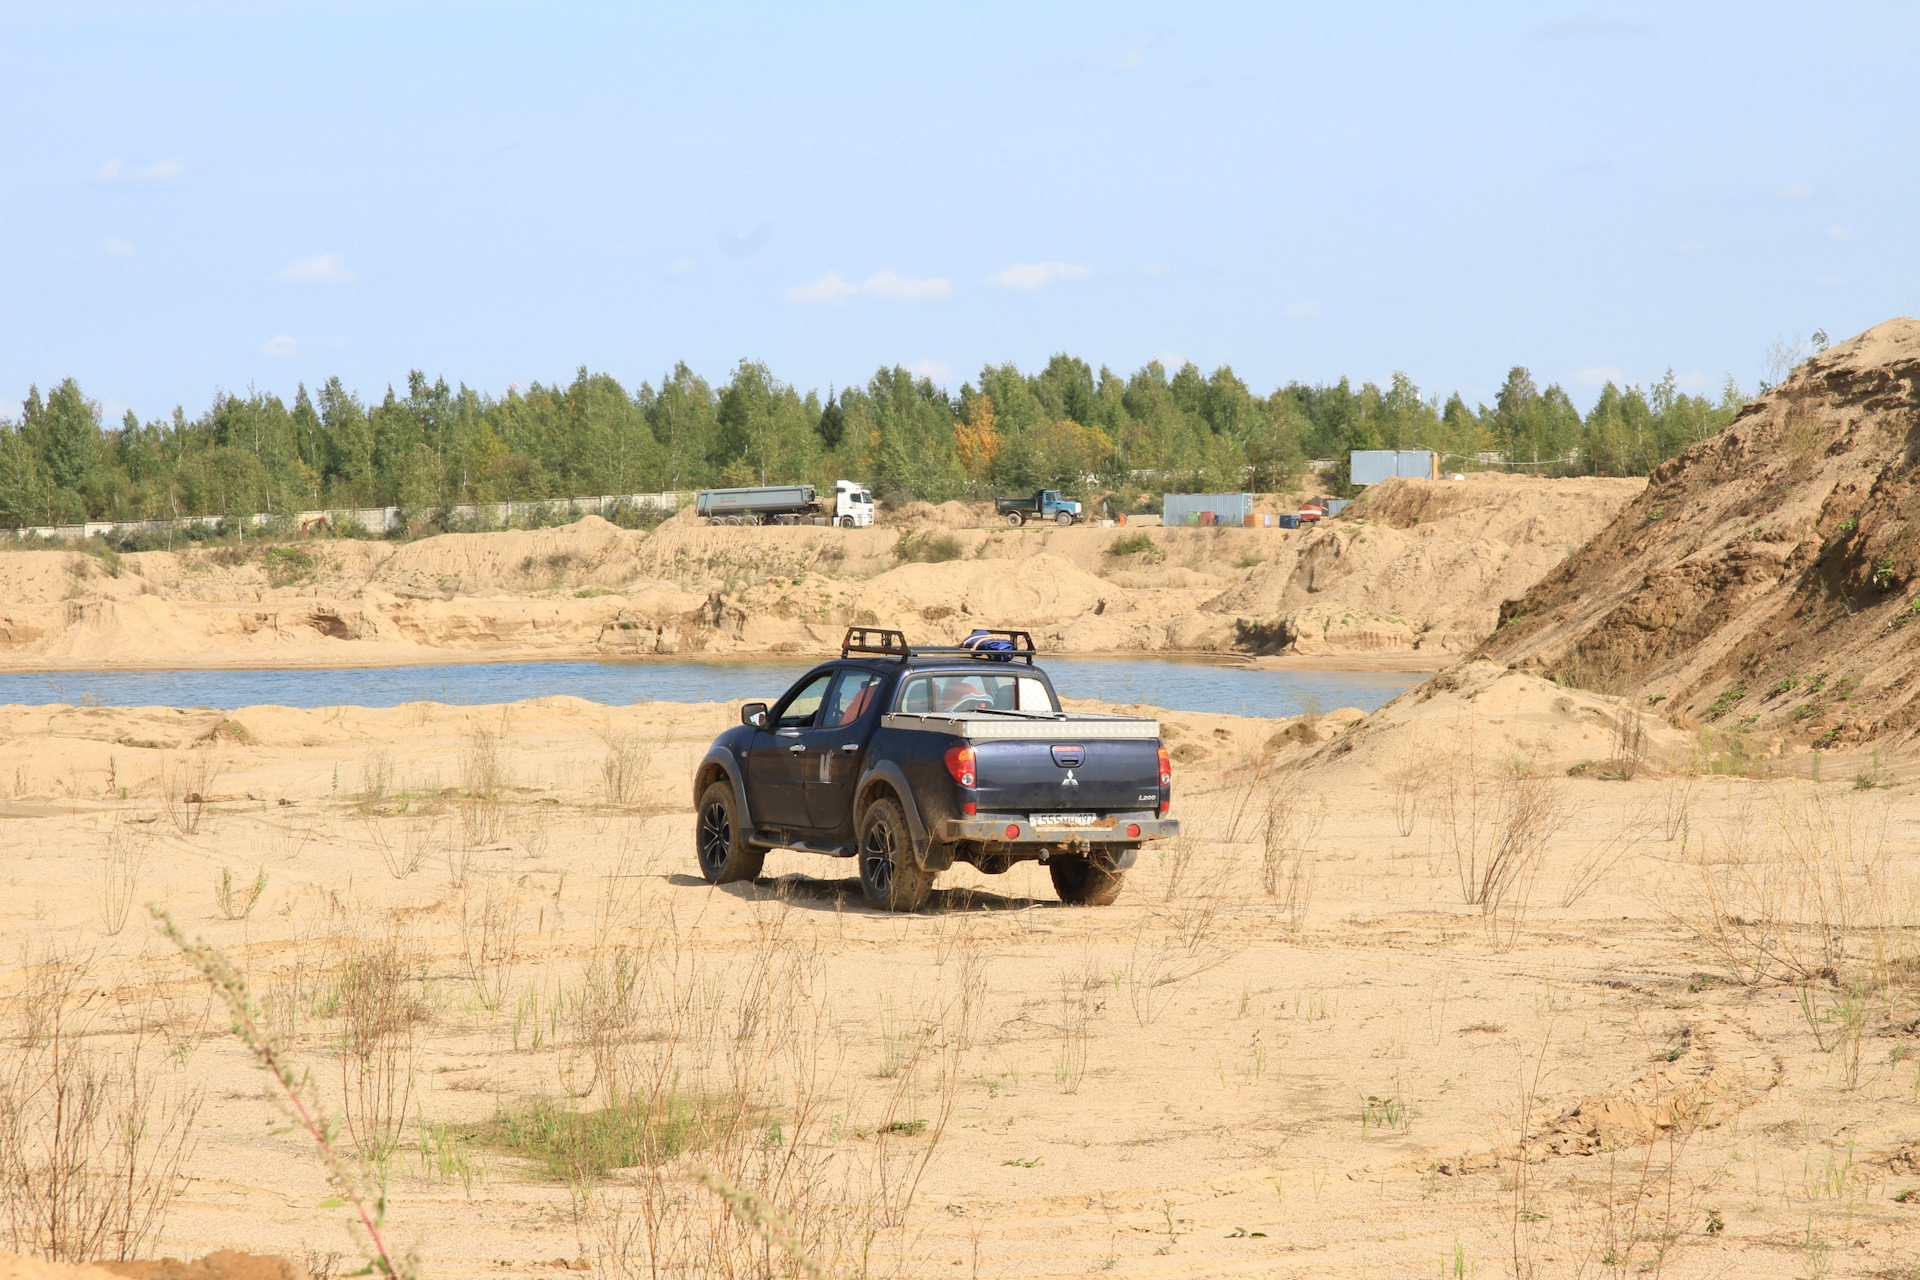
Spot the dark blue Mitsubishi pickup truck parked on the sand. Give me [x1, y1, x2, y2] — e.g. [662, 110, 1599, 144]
[693, 628, 1179, 912]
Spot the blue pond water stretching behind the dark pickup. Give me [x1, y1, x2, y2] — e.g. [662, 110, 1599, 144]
[0, 658, 1425, 716]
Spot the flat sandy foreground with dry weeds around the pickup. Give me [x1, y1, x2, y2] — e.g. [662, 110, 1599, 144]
[0, 699, 1920, 1278]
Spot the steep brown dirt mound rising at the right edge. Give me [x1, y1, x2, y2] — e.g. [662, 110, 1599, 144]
[1478, 319, 1920, 748]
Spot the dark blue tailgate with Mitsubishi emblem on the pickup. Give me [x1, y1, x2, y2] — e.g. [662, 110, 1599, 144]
[973, 725, 1160, 814]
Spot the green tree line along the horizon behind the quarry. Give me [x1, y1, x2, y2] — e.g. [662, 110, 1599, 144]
[0, 355, 1743, 526]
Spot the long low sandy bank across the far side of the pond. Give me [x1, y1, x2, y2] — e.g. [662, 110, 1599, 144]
[0, 476, 1642, 668]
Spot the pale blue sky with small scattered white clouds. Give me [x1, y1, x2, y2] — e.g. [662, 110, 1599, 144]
[0, 0, 1920, 420]
